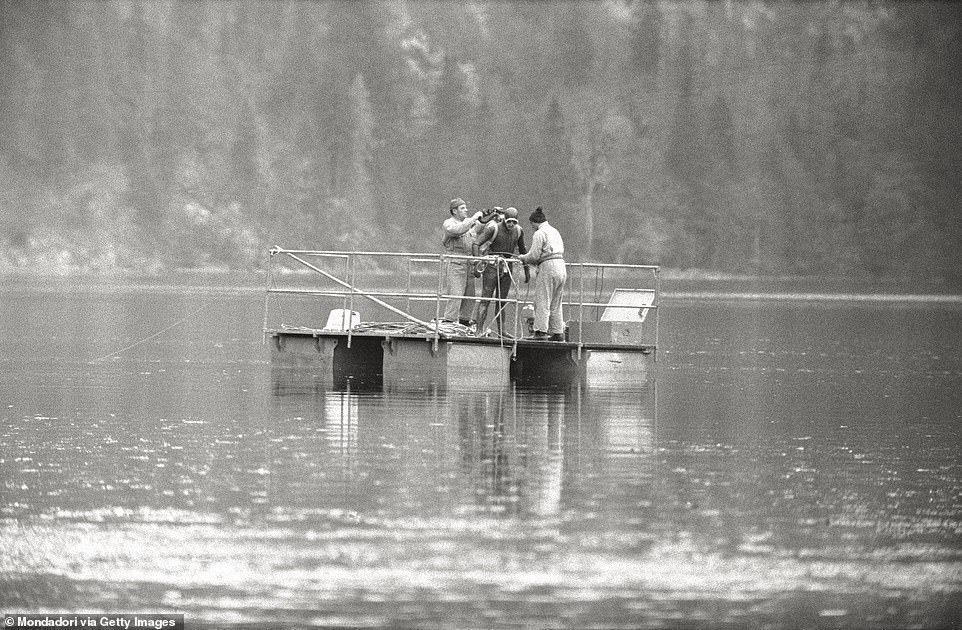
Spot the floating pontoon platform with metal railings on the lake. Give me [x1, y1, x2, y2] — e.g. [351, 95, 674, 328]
[264, 249, 659, 389]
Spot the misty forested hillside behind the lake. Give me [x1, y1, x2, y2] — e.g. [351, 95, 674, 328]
[0, 0, 962, 286]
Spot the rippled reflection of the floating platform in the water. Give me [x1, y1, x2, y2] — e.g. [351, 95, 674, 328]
[271, 383, 656, 527]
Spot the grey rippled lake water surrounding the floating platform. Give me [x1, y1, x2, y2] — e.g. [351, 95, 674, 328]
[0, 276, 962, 628]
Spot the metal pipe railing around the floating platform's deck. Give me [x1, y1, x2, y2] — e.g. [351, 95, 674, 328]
[264, 247, 661, 356]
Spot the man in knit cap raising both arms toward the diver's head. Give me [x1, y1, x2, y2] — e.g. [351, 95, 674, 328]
[441, 197, 482, 326]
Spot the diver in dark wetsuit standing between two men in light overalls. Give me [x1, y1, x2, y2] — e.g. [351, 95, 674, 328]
[471, 208, 529, 337]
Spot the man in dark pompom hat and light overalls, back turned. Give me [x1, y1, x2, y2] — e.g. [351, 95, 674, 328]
[518, 206, 568, 341]
